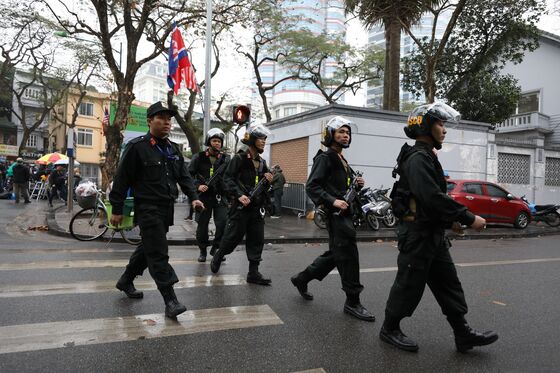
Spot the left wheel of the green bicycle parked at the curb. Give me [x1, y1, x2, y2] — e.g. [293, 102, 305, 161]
[70, 206, 109, 241]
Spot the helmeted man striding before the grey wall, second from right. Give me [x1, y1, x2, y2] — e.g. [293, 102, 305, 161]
[291, 117, 375, 321]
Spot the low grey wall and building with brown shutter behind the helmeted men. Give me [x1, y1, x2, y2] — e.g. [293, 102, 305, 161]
[265, 105, 560, 204]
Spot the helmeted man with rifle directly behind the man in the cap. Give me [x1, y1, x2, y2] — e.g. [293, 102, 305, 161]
[189, 128, 229, 262]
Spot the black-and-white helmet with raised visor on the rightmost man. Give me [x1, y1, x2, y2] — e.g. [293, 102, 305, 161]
[404, 102, 461, 139]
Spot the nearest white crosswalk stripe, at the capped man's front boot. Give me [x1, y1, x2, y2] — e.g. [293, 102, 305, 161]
[0, 305, 283, 354]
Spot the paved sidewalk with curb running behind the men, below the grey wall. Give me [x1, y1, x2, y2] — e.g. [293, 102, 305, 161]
[43, 201, 560, 246]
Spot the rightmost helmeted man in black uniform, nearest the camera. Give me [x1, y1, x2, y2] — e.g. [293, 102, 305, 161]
[379, 103, 498, 352]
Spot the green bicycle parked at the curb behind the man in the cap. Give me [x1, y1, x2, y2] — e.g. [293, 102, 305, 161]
[70, 191, 142, 245]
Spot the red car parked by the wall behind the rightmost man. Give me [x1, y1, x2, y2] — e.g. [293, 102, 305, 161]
[447, 180, 531, 229]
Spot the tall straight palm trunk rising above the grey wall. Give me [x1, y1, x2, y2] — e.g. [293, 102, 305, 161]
[384, 18, 401, 111]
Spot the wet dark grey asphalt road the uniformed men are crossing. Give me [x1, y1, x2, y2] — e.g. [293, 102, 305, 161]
[0, 201, 560, 372]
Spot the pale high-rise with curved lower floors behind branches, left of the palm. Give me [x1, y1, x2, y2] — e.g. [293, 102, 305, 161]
[253, 0, 346, 119]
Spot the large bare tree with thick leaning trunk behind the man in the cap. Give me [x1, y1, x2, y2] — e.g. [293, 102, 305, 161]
[43, 0, 250, 187]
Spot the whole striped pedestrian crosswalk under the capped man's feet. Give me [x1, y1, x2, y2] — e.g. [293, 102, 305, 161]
[0, 238, 283, 365]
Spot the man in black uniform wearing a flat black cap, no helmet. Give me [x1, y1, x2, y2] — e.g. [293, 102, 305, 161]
[109, 102, 204, 318]
